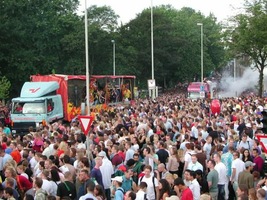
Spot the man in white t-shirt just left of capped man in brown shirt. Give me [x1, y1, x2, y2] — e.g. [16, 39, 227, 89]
[230, 151, 245, 198]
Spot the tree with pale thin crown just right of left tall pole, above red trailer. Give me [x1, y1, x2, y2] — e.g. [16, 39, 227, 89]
[87, 5, 119, 75]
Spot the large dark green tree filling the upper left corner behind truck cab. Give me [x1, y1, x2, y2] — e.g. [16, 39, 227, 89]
[0, 0, 81, 95]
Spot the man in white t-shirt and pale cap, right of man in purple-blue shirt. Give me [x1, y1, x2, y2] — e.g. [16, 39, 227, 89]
[98, 151, 114, 199]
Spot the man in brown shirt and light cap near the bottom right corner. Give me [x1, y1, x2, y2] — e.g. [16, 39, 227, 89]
[238, 161, 255, 189]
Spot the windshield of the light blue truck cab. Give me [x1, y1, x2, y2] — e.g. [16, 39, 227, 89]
[12, 101, 46, 114]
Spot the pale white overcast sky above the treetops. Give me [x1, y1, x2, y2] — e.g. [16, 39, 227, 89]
[78, 0, 244, 23]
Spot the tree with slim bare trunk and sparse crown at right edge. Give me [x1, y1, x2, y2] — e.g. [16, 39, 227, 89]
[225, 0, 267, 96]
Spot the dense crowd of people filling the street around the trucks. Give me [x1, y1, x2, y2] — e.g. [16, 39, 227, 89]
[0, 94, 267, 200]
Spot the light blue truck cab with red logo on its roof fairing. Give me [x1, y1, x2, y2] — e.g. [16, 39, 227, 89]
[11, 81, 64, 135]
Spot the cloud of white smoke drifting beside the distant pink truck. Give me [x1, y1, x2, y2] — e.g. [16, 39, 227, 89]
[219, 67, 259, 97]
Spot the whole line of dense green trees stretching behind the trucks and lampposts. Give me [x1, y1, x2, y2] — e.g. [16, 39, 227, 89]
[0, 0, 267, 97]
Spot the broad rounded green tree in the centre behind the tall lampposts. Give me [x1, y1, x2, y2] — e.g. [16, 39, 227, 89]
[119, 5, 224, 87]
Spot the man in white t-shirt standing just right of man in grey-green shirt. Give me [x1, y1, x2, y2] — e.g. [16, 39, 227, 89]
[213, 153, 228, 200]
